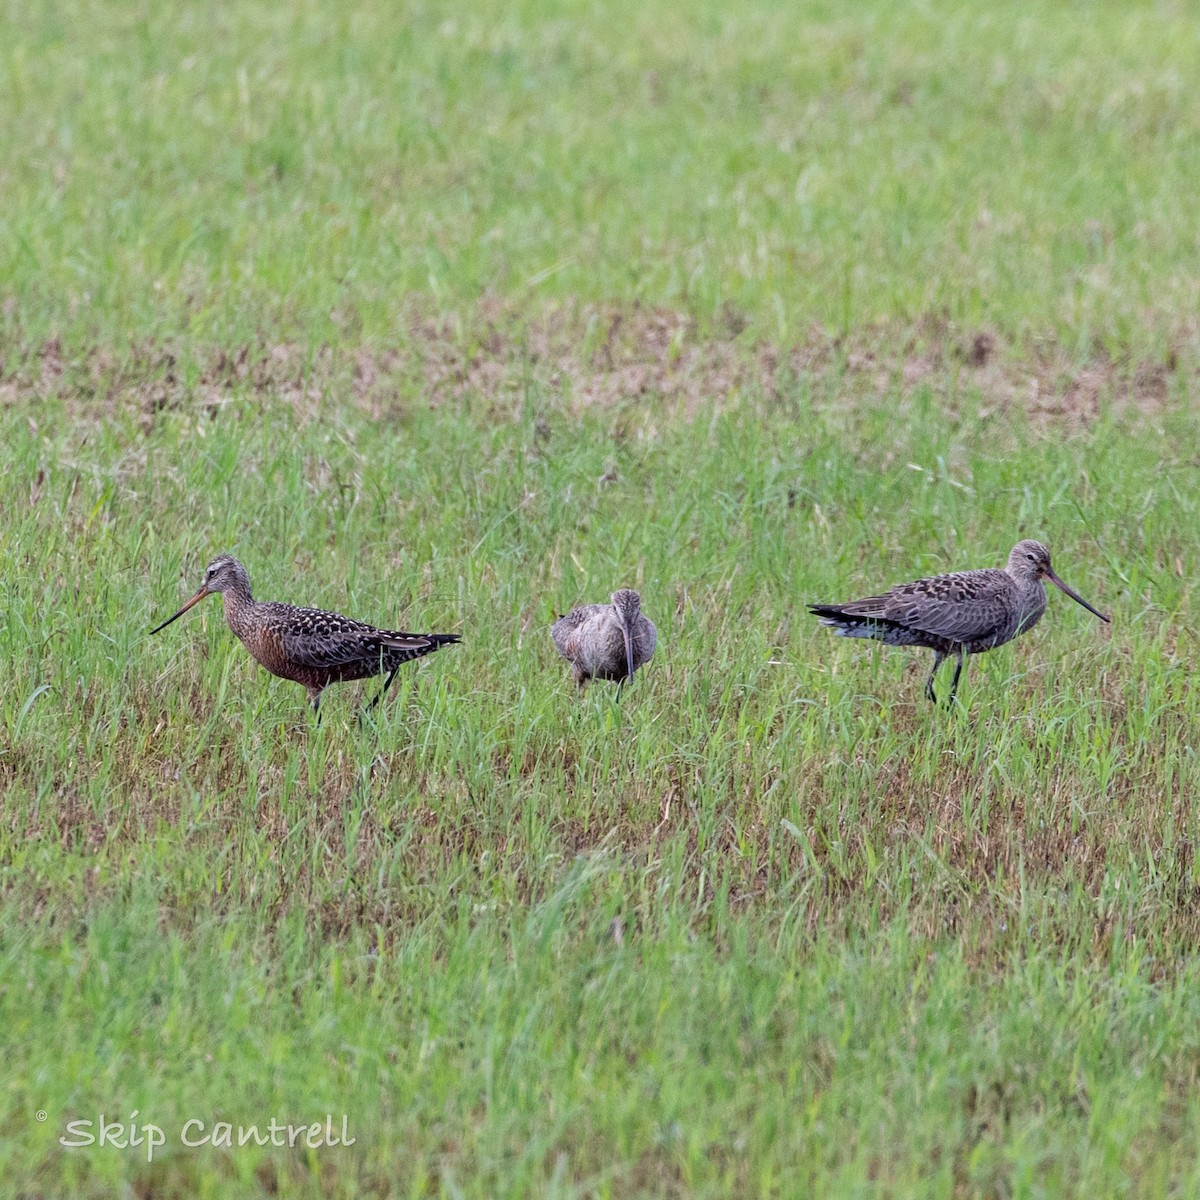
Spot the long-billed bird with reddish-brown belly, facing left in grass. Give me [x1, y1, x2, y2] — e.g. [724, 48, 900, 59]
[150, 554, 461, 721]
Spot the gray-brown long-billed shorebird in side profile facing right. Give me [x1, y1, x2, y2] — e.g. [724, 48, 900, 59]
[809, 540, 1109, 704]
